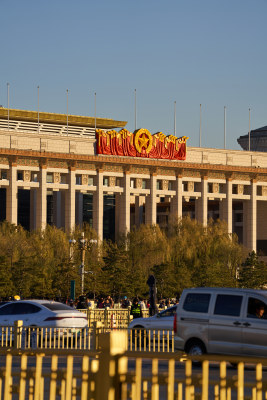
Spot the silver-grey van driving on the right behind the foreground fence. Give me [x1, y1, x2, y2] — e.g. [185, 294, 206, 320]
[174, 288, 267, 357]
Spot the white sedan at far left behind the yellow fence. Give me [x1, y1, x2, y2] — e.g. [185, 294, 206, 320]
[0, 300, 88, 328]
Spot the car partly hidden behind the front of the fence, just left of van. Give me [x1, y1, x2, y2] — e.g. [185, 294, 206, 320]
[129, 305, 177, 331]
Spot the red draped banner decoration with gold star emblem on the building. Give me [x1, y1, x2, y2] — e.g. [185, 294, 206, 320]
[96, 129, 188, 160]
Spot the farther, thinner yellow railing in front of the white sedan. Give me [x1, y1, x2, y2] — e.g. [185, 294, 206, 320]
[0, 321, 174, 353]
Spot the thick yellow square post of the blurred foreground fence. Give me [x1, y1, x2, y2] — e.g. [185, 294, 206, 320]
[96, 331, 128, 400]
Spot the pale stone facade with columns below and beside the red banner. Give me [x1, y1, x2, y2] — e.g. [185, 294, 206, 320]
[0, 109, 267, 252]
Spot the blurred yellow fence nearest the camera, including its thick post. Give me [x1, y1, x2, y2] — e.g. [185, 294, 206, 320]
[0, 331, 267, 400]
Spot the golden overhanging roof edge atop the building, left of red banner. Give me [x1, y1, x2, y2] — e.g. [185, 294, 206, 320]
[0, 107, 127, 129]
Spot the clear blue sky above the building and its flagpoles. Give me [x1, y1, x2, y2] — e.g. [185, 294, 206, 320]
[0, 0, 267, 149]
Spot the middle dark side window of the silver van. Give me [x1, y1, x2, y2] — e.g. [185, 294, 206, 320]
[214, 294, 243, 317]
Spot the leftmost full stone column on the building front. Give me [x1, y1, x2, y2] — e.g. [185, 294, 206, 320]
[6, 160, 18, 225]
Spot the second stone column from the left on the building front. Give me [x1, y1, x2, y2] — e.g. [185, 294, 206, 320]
[36, 164, 47, 230]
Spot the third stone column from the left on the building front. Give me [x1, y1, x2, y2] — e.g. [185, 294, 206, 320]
[65, 166, 76, 232]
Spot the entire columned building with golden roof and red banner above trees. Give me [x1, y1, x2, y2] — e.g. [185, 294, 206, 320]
[0, 107, 267, 255]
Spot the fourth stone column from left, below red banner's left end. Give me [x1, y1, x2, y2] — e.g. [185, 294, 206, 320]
[93, 169, 104, 241]
